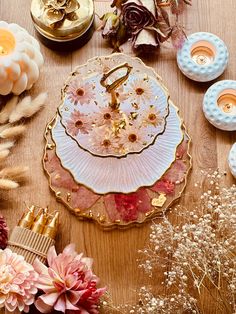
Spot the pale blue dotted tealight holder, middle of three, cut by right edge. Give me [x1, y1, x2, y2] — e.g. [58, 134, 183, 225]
[203, 80, 236, 131]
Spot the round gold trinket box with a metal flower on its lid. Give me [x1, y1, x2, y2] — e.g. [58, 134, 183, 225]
[31, 0, 94, 49]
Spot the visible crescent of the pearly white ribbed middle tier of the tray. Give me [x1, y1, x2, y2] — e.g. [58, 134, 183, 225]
[52, 102, 183, 194]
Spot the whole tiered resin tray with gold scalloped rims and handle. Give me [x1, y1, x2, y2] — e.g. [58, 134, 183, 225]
[43, 54, 191, 228]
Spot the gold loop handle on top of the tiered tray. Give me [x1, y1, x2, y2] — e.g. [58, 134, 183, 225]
[100, 63, 132, 110]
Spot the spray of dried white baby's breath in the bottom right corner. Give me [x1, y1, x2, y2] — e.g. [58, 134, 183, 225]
[103, 171, 236, 314]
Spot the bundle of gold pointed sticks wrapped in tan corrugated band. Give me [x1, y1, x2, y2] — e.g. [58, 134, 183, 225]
[8, 206, 59, 264]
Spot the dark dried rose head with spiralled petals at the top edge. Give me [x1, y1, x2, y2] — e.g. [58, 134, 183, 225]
[122, 0, 156, 35]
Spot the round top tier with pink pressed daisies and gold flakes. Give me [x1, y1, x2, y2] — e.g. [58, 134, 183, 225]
[59, 54, 169, 158]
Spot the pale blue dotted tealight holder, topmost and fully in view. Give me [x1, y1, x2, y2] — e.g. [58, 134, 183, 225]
[177, 32, 229, 82]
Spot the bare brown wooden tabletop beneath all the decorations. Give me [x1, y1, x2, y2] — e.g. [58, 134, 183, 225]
[0, 0, 236, 314]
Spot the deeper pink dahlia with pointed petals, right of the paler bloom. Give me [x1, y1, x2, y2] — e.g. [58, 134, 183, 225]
[34, 244, 106, 314]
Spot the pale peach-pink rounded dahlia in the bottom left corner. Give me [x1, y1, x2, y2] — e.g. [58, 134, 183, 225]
[0, 249, 38, 313]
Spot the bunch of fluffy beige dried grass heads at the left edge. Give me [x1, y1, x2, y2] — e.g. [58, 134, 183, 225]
[0, 93, 47, 190]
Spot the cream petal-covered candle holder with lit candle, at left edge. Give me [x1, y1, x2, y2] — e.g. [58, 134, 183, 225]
[0, 21, 43, 95]
